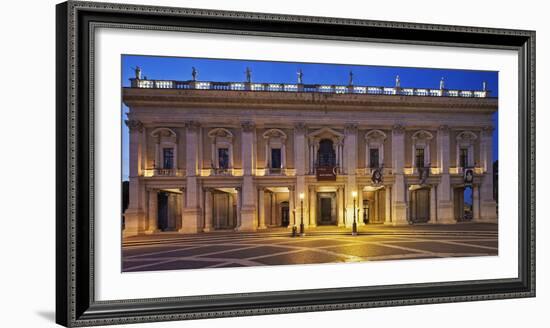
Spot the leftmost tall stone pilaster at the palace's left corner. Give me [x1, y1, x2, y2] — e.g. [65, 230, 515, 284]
[123, 120, 147, 236]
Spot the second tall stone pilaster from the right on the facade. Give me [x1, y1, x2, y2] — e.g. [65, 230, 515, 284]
[437, 125, 455, 223]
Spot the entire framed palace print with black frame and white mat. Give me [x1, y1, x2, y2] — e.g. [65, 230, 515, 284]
[56, 1, 535, 326]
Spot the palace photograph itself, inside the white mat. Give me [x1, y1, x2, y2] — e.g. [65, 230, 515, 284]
[123, 54, 499, 272]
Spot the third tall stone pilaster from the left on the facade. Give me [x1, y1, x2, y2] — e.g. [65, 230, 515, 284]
[239, 122, 258, 231]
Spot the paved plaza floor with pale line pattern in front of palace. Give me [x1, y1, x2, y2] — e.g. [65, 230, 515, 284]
[122, 223, 498, 272]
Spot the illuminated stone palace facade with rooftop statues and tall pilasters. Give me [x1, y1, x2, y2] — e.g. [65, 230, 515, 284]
[123, 74, 498, 235]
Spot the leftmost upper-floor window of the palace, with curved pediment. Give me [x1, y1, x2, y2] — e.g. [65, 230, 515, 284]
[151, 128, 178, 170]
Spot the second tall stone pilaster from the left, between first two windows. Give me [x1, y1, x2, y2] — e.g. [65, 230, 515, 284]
[181, 121, 202, 233]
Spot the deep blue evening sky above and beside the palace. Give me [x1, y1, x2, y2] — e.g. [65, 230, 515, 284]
[121, 55, 498, 191]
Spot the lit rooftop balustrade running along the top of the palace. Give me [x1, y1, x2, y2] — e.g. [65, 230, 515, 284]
[130, 78, 490, 98]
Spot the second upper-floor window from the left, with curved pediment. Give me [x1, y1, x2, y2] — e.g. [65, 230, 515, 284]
[208, 128, 233, 174]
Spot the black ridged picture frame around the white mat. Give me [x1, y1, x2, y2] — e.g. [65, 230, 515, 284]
[56, 1, 535, 326]
